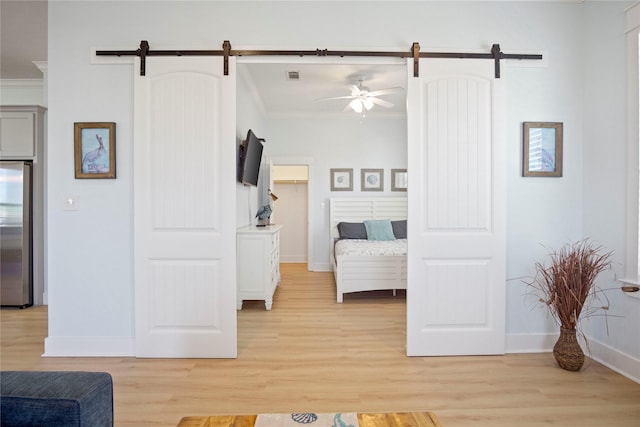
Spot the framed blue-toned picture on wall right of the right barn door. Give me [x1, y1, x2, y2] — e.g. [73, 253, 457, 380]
[522, 122, 563, 177]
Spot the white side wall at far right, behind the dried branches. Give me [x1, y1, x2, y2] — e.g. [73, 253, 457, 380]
[582, 2, 640, 379]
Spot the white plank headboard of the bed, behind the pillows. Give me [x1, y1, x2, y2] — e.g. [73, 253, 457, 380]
[329, 197, 407, 241]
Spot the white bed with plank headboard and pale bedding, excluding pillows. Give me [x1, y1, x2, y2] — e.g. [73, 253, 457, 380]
[329, 197, 407, 303]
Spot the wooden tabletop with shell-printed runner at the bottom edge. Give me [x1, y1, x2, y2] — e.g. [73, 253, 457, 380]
[178, 412, 441, 427]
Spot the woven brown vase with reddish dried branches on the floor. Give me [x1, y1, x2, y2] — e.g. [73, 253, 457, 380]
[530, 239, 613, 371]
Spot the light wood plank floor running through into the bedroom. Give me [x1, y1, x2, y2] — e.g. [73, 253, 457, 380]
[0, 264, 640, 427]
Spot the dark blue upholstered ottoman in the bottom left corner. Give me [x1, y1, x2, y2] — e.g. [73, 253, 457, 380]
[0, 371, 113, 427]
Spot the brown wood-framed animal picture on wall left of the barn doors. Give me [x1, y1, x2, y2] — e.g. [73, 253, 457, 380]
[73, 122, 116, 179]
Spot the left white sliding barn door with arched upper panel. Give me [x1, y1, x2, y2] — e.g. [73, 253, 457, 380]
[133, 57, 237, 358]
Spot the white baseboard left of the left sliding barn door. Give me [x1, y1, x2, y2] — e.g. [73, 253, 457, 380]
[42, 337, 136, 357]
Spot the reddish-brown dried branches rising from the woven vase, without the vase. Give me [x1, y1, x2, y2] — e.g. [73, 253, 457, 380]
[531, 239, 613, 330]
